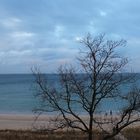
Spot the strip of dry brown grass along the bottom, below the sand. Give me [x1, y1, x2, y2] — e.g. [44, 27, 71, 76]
[0, 127, 140, 140]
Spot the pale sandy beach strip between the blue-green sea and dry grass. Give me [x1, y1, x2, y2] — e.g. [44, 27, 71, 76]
[0, 114, 140, 130]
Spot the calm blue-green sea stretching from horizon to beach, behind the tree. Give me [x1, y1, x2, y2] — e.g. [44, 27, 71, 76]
[0, 74, 140, 114]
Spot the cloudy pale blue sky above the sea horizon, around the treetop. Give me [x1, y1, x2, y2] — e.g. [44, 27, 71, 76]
[0, 0, 140, 73]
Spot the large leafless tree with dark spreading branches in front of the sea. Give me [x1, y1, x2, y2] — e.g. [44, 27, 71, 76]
[34, 34, 140, 140]
